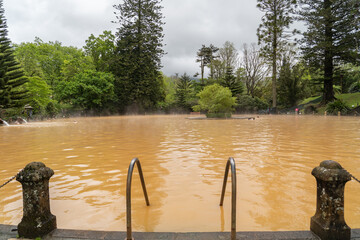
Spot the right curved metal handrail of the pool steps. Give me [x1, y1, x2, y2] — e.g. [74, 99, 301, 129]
[220, 157, 236, 240]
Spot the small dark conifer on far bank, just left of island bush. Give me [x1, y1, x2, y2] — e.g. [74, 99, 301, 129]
[175, 73, 193, 110]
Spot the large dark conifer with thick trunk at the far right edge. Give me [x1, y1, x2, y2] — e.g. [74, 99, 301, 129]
[299, 0, 360, 103]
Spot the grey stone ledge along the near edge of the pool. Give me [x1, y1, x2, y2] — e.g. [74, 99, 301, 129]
[0, 224, 360, 240]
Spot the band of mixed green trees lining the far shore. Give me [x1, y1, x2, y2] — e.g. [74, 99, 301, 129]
[0, 0, 360, 118]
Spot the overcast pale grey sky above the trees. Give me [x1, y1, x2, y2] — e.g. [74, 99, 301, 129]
[3, 0, 262, 75]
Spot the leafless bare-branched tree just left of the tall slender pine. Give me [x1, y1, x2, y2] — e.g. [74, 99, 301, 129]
[241, 43, 268, 98]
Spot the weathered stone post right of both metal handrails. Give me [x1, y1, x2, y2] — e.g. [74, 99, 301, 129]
[310, 160, 351, 240]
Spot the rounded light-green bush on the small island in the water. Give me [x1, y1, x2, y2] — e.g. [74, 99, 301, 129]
[193, 84, 236, 113]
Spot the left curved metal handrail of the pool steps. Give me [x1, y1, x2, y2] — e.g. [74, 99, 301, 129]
[126, 158, 150, 240]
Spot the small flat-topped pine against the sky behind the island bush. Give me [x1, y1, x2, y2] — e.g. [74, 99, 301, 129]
[196, 44, 219, 85]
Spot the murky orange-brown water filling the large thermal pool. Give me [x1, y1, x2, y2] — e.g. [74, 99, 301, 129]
[0, 116, 360, 232]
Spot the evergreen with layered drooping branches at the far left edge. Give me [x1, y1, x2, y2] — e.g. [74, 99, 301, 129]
[0, 0, 27, 109]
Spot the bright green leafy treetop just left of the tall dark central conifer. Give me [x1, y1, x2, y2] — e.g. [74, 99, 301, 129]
[84, 31, 116, 72]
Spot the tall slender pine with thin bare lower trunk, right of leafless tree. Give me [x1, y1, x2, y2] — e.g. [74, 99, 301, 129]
[257, 0, 296, 108]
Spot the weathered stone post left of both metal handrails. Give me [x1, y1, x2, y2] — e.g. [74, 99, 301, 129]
[16, 162, 56, 238]
